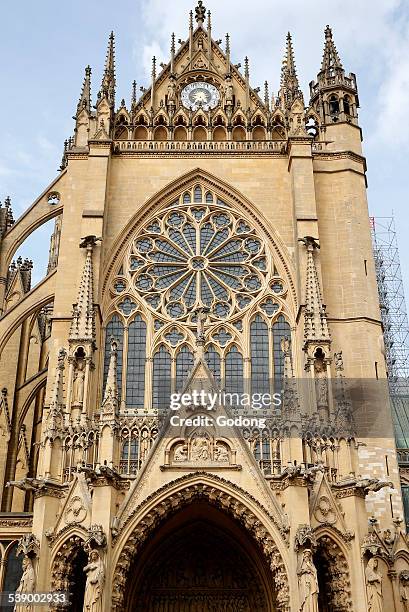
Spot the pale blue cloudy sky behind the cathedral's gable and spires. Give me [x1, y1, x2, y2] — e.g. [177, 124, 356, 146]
[0, 0, 409, 306]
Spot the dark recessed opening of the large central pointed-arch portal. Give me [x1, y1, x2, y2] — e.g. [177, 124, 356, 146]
[124, 501, 276, 612]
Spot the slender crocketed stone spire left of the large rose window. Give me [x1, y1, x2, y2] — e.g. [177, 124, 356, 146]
[69, 236, 98, 343]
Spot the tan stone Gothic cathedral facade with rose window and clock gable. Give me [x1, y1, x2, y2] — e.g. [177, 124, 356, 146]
[0, 2, 409, 612]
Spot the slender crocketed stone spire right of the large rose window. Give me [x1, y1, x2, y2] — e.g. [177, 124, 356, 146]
[300, 236, 330, 348]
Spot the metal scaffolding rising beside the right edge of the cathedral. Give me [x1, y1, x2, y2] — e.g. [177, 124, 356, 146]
[370, 217, 409, 450]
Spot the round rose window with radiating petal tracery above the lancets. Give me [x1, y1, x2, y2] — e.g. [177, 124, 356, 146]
[114, 192, 268, 322]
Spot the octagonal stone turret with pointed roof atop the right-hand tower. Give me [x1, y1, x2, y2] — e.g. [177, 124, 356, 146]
[310, 26, 359, 125]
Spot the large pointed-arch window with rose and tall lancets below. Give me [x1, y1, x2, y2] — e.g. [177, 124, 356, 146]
[104, 184, 291, 412]
